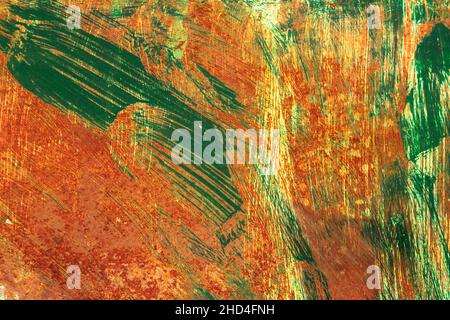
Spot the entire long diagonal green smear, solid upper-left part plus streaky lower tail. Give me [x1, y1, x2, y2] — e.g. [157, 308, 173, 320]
[0, 2, 242, 225]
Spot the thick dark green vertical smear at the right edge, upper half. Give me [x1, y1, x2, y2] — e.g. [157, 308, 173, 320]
[400, 23, 450, 160]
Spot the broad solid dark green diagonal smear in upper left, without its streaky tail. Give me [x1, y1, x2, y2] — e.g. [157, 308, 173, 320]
[3, 6, 159, 129]
